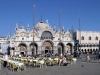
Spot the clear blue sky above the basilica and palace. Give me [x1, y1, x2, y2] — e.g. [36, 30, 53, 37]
[0, 0, 100, 37]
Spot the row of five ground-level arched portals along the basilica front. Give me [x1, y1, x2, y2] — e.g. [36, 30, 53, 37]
[13, 40, 72, 55]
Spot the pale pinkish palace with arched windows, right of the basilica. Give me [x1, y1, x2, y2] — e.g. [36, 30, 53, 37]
[74, 31, 100, 52]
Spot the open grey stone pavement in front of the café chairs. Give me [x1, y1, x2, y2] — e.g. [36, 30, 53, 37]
[0, 58, 100, 75]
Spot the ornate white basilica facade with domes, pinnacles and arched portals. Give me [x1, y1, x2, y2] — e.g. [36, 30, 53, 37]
[8, 19, 75, 55]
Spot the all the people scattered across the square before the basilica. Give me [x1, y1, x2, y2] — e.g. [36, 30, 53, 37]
[0, 50, 100, 67]
